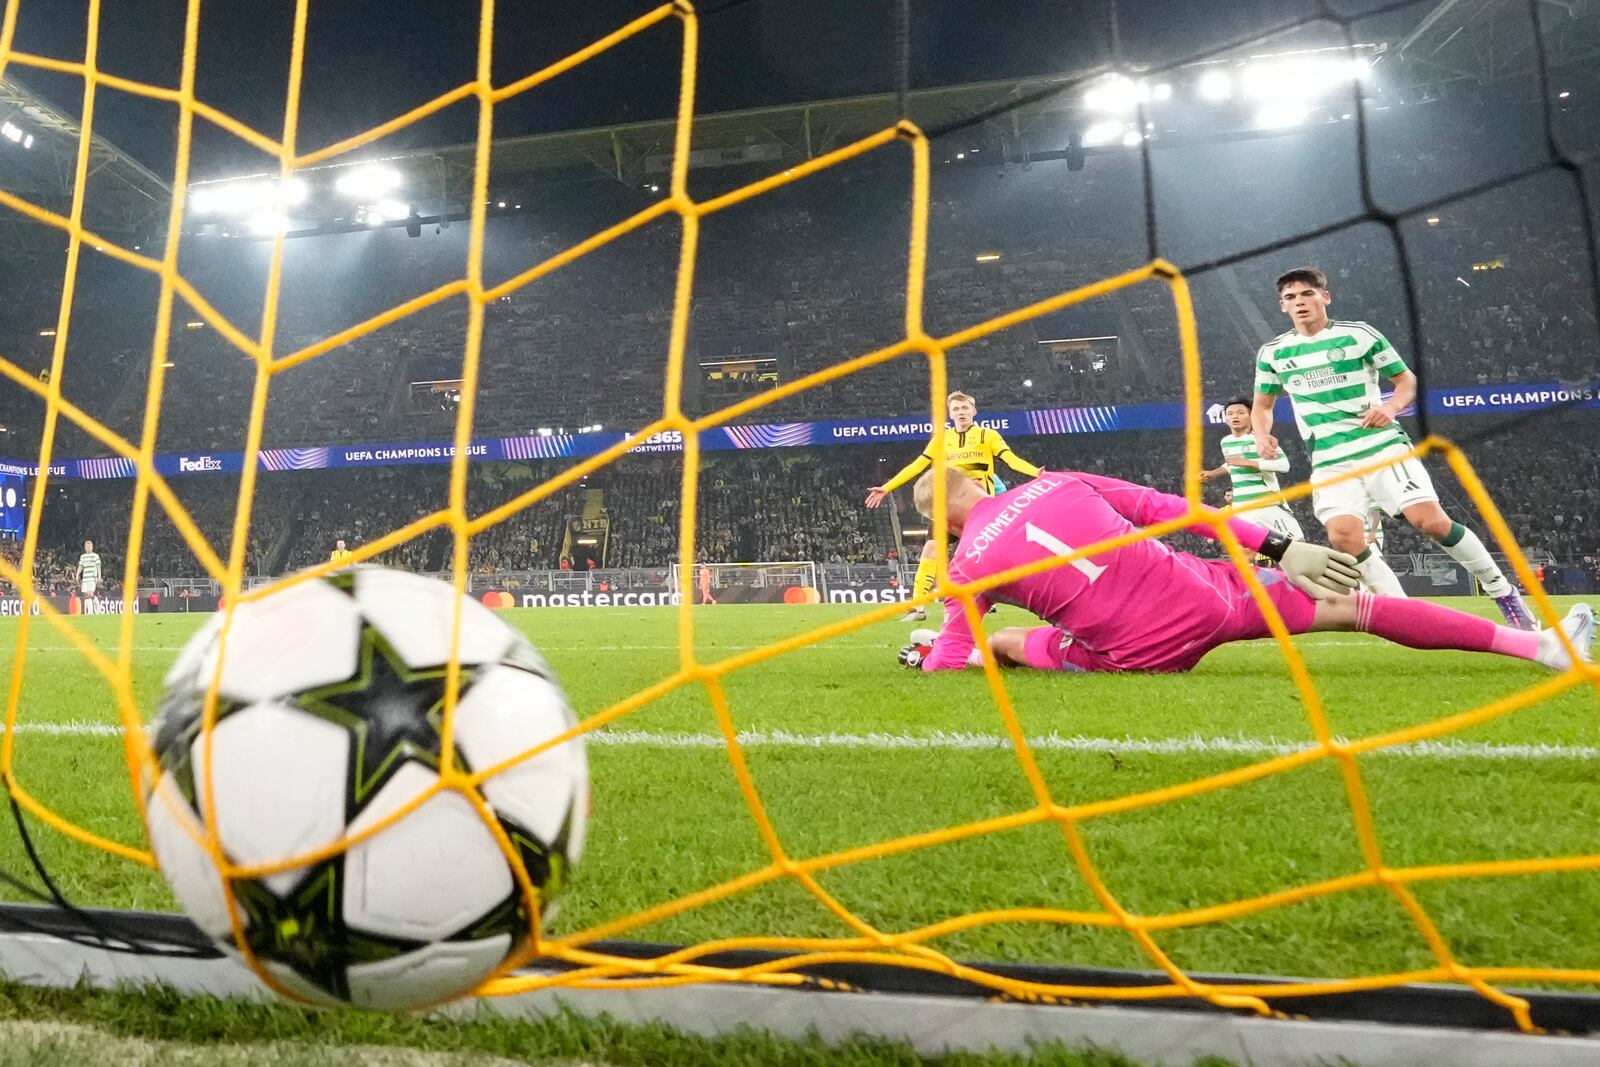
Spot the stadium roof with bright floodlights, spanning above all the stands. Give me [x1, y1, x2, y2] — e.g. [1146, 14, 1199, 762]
[31, 0, 1580, 237]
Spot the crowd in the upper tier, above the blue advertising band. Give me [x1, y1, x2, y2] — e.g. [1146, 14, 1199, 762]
[0, 84, 1600, 467]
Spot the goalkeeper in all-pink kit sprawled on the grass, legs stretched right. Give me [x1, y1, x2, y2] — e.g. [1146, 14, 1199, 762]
[901, 469, 1595, 670]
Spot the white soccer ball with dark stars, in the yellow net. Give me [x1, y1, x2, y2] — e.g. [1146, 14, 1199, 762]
[147, 566, 589, 1009]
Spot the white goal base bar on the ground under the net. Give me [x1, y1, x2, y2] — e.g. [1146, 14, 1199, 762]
[0, 933, 1600, 1067]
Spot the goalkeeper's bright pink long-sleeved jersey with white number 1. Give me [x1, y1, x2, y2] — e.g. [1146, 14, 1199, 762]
[922, 470, 1269, 670]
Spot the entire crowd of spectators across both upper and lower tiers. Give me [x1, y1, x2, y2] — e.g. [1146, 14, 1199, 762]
[0, 83, 1600, 591]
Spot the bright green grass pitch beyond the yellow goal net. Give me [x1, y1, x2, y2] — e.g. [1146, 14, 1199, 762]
[0, 600, 1600, 1062]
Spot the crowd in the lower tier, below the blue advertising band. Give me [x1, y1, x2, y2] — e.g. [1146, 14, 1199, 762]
[6, 411, 1600, 587]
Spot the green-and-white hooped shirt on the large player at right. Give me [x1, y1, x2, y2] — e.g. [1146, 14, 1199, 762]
[1256, 322, 1411, 469]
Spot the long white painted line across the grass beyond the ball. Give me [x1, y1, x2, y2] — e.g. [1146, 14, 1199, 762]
[16, 720, 1600, 760]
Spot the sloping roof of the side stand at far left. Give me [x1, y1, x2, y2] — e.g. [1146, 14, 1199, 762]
[0, 74, 173, 235]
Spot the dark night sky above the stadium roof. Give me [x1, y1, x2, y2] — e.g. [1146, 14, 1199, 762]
[3, 0, 1363, 176]
